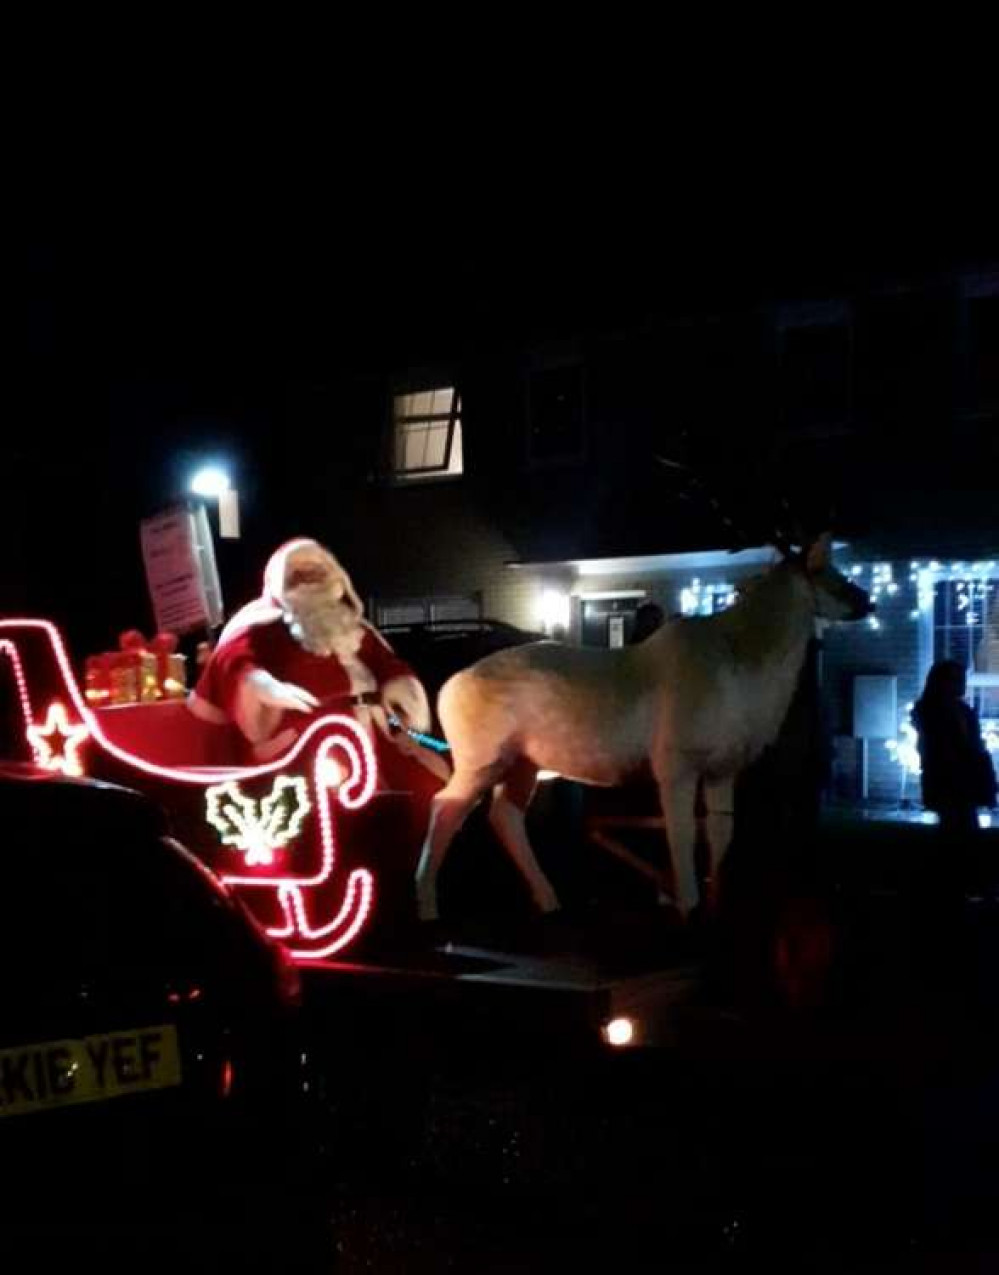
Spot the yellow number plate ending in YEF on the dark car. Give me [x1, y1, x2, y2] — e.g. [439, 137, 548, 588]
[0, 1024, 181, 1116]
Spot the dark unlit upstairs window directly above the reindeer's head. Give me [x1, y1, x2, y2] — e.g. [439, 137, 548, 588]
[777, 302, 852, 434]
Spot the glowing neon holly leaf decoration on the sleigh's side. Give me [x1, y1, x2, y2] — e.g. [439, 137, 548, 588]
[205, 775, 312, 867]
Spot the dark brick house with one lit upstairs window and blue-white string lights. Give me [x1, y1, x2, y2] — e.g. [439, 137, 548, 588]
[286, 263, 999, 802]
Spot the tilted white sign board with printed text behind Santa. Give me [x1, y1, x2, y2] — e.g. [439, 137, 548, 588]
[141, 506, 222, 634]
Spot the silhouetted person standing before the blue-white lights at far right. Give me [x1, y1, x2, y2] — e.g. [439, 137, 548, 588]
[912, 659, 996, 845]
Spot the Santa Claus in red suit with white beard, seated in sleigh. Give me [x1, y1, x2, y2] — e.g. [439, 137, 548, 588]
[189, 539, 447, 788]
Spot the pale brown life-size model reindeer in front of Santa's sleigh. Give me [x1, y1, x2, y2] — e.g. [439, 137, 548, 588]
[417, 522, 872, 921]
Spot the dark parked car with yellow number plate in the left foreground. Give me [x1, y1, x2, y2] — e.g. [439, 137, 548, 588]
[0, 762, 308, 1230]
